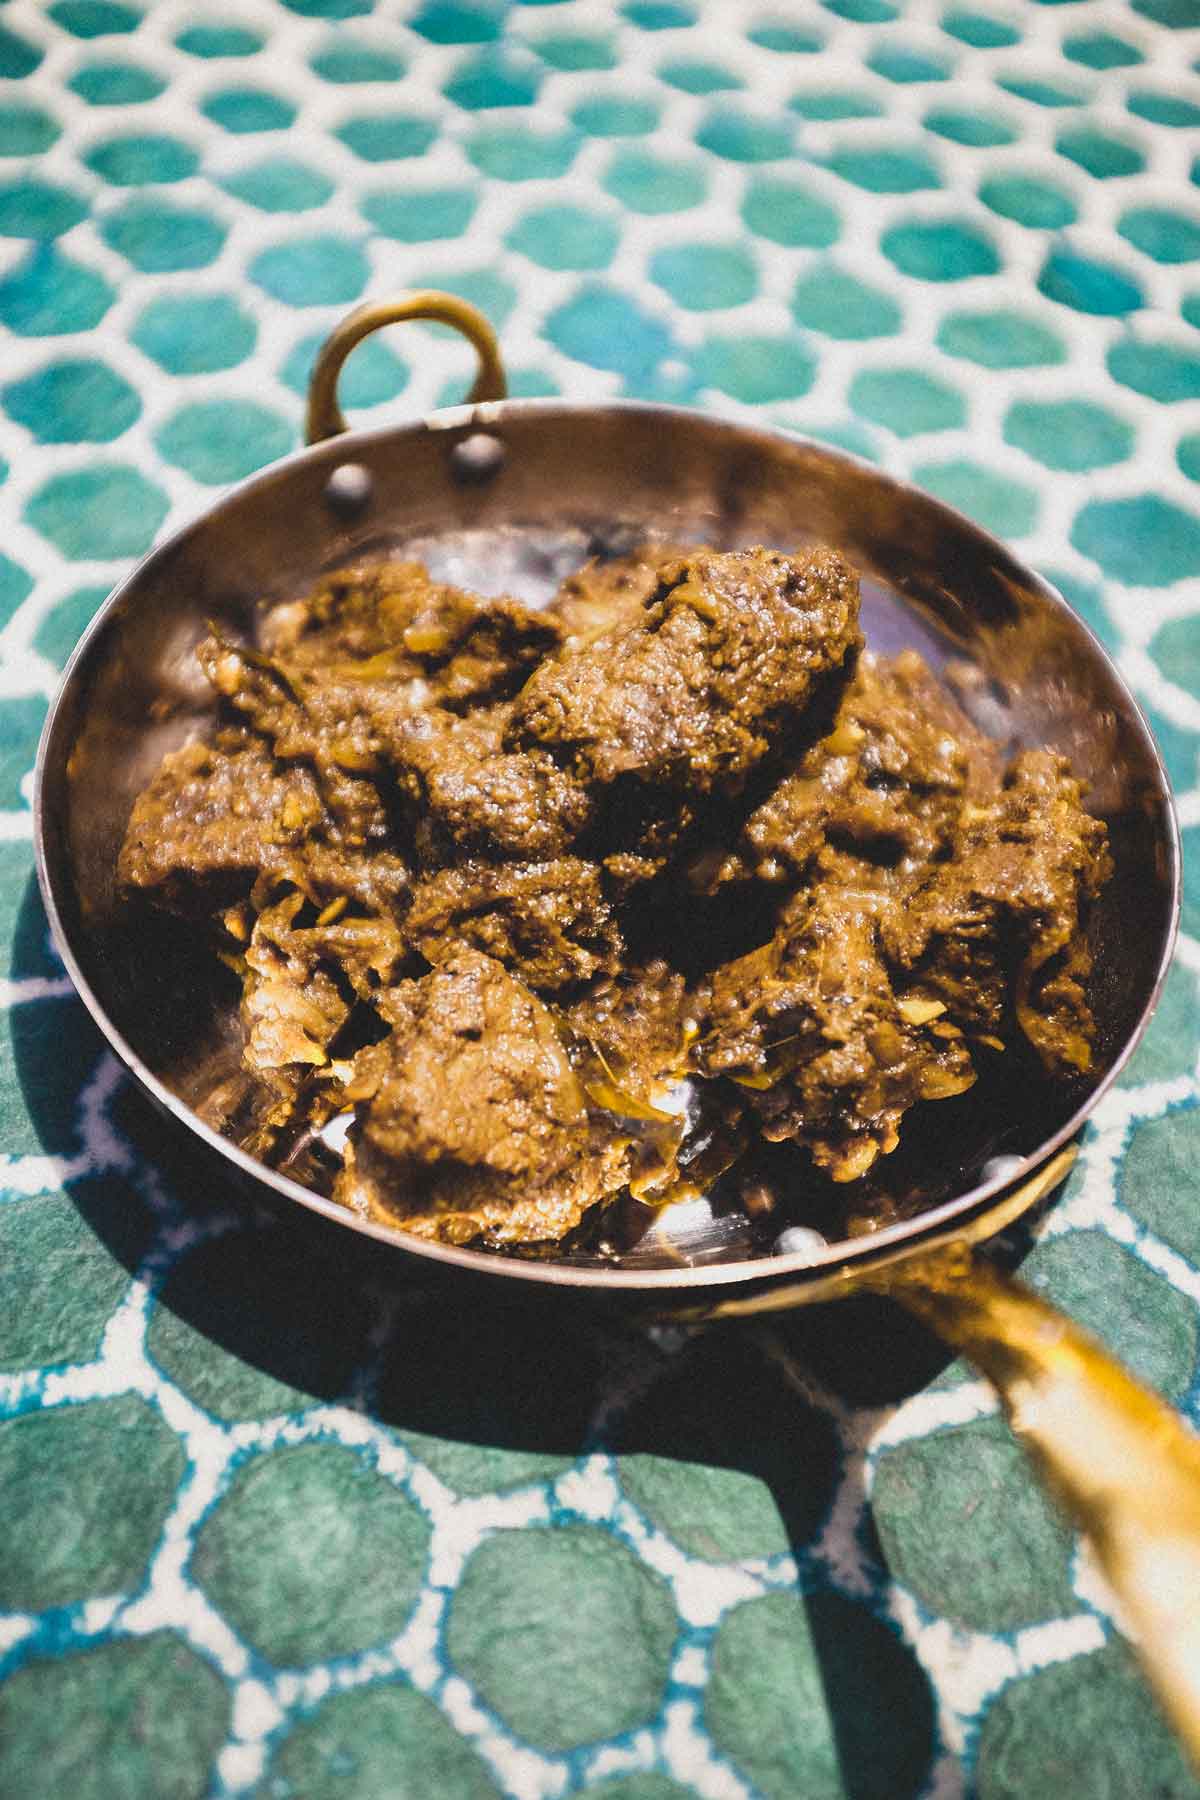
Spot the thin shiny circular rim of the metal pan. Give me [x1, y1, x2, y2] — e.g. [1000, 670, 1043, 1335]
[32, 396, 1182, 1292]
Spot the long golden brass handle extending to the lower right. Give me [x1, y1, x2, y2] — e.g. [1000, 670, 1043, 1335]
[888, 1247, 1200, 1768]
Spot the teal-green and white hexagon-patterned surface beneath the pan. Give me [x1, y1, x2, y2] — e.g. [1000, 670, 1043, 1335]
[0, 0, 1200, 1800]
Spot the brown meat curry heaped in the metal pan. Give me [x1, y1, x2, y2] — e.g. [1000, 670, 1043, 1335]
[119, 545, 1110, 1251]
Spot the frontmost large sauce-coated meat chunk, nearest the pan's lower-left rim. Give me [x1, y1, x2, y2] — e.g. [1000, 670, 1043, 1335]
[336, 950, 626, 1244]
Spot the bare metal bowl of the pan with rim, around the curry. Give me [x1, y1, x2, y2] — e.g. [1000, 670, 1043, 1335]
[36, 401, 1178, 1289]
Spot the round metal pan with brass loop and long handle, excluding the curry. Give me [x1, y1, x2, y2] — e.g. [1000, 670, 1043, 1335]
[34, 293, 1200, 1762]
